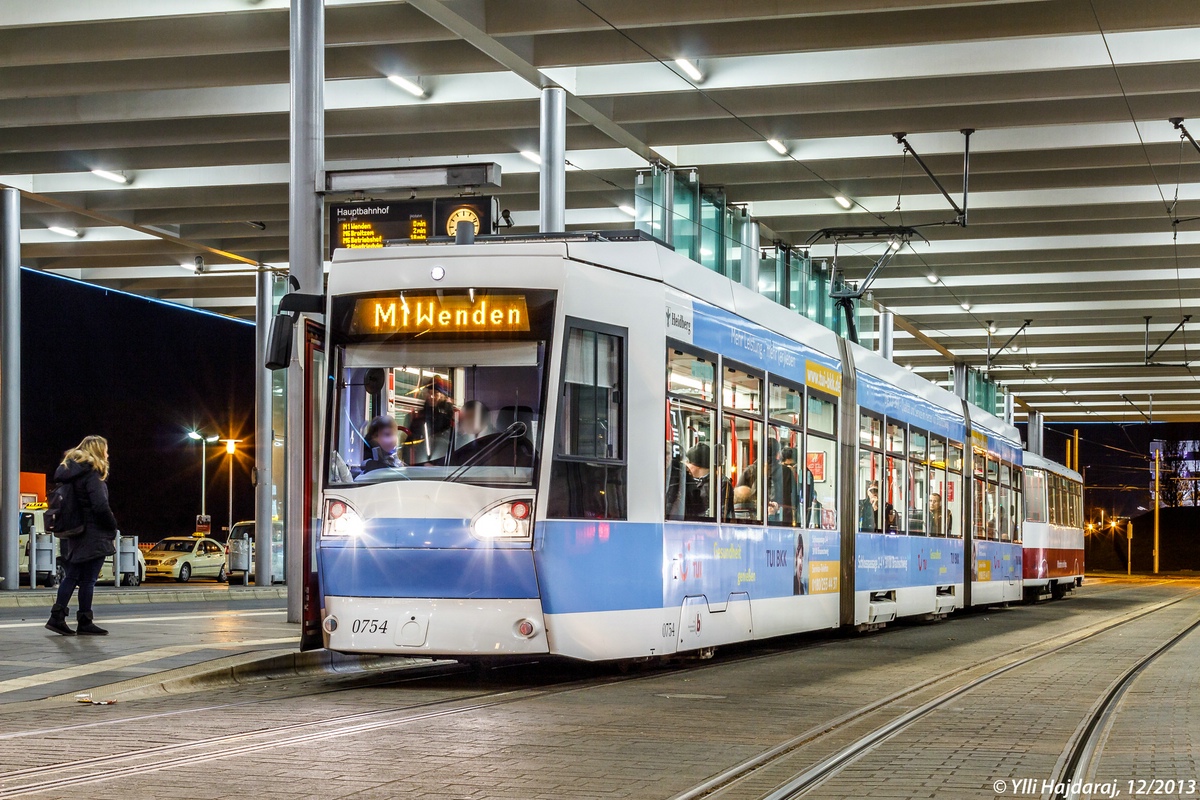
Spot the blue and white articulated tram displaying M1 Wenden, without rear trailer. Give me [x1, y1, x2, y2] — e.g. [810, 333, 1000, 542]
[316, 235, 1024, 660]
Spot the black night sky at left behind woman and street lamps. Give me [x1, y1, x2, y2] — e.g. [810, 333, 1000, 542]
[20, 270, 254, 541]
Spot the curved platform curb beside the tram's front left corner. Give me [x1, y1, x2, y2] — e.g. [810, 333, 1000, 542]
[59, 649, 436, 702]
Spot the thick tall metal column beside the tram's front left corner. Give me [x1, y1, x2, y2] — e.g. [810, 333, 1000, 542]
[284, 0, 325, 622]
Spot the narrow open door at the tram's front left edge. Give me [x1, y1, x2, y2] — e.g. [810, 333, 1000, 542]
[300, 320, 329, 650]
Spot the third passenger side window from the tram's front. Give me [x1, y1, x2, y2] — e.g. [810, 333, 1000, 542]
[767, 383, 812, 527]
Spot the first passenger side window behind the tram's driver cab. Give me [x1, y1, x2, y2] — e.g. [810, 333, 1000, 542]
[665, 349, 733, 522]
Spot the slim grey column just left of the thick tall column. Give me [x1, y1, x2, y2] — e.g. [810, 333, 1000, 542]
[254, 270, 275, 587]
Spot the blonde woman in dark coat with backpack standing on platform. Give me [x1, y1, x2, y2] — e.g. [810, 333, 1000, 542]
[46, 437, 116, 636]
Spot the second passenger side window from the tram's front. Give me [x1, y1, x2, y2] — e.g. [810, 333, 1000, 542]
[720, 366, 763, 524]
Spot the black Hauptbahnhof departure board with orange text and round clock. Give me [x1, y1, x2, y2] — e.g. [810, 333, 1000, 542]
[329, 197, 496, 257]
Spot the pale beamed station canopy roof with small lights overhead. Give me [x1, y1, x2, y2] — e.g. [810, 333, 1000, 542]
[0, 0, 1200, 421]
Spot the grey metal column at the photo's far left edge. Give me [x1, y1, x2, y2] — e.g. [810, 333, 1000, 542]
[0, 188, 20, 591]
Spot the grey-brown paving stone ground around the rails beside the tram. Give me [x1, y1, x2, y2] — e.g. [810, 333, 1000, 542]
[0, 581, 1200, 800]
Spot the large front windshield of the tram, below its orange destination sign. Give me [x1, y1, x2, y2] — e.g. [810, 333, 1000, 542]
[329, 287, 546, 487]
